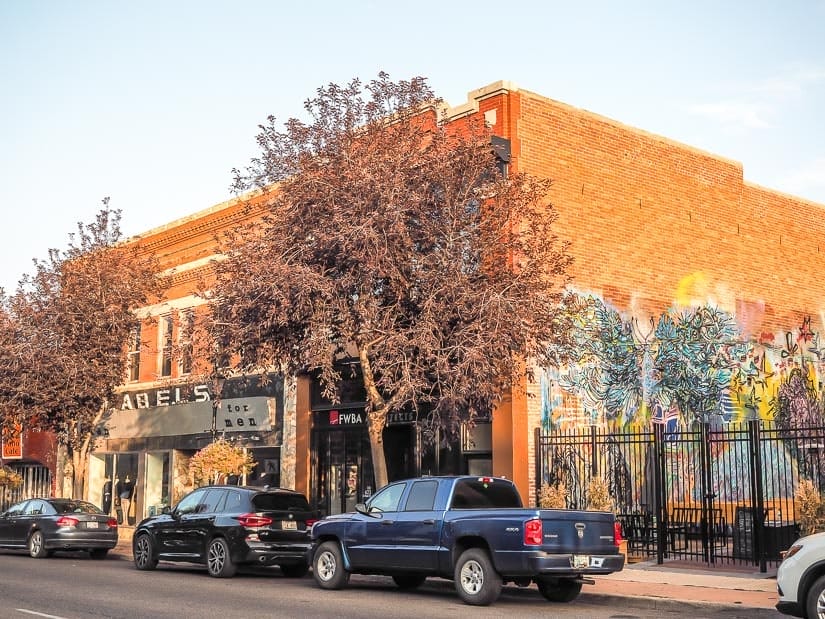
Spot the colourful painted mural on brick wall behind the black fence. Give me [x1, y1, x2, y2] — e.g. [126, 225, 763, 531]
[540, 293, 825, 501]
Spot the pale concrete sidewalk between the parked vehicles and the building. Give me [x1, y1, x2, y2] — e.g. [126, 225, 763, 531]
[110, 527, 779, 611]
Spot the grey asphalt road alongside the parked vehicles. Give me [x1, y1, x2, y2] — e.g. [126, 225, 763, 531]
[0, 551, 780, 619]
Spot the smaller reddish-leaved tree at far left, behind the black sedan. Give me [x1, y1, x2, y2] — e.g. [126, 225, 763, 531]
[0, 203, 164, 497]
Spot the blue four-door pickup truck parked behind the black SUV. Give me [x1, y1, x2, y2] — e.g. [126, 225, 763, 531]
[310, 476, 624, 606]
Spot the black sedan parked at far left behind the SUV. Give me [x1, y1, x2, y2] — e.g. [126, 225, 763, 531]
[0, 498, 117, 559]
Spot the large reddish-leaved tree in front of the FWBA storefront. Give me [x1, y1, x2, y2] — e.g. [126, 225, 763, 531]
[211, 73, 570, 487]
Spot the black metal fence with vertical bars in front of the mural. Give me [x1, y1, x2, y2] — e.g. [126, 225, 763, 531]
[536, 420, 825, 572]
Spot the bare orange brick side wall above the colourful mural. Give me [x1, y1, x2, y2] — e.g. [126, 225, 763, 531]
[497, 91, 825, 331]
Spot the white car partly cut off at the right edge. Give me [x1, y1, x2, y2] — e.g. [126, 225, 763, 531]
[776, 533, 825, 619]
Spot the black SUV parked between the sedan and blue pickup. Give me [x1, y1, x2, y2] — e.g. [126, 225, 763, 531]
[132, 486, 318, 578]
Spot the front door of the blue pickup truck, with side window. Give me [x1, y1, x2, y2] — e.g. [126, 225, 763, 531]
[346, 482, 407, 569]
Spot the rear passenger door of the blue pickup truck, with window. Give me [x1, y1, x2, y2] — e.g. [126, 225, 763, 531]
[391, 479, 442, 572]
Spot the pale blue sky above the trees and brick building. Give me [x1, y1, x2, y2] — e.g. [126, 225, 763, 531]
[0, 0, 825, 292]
